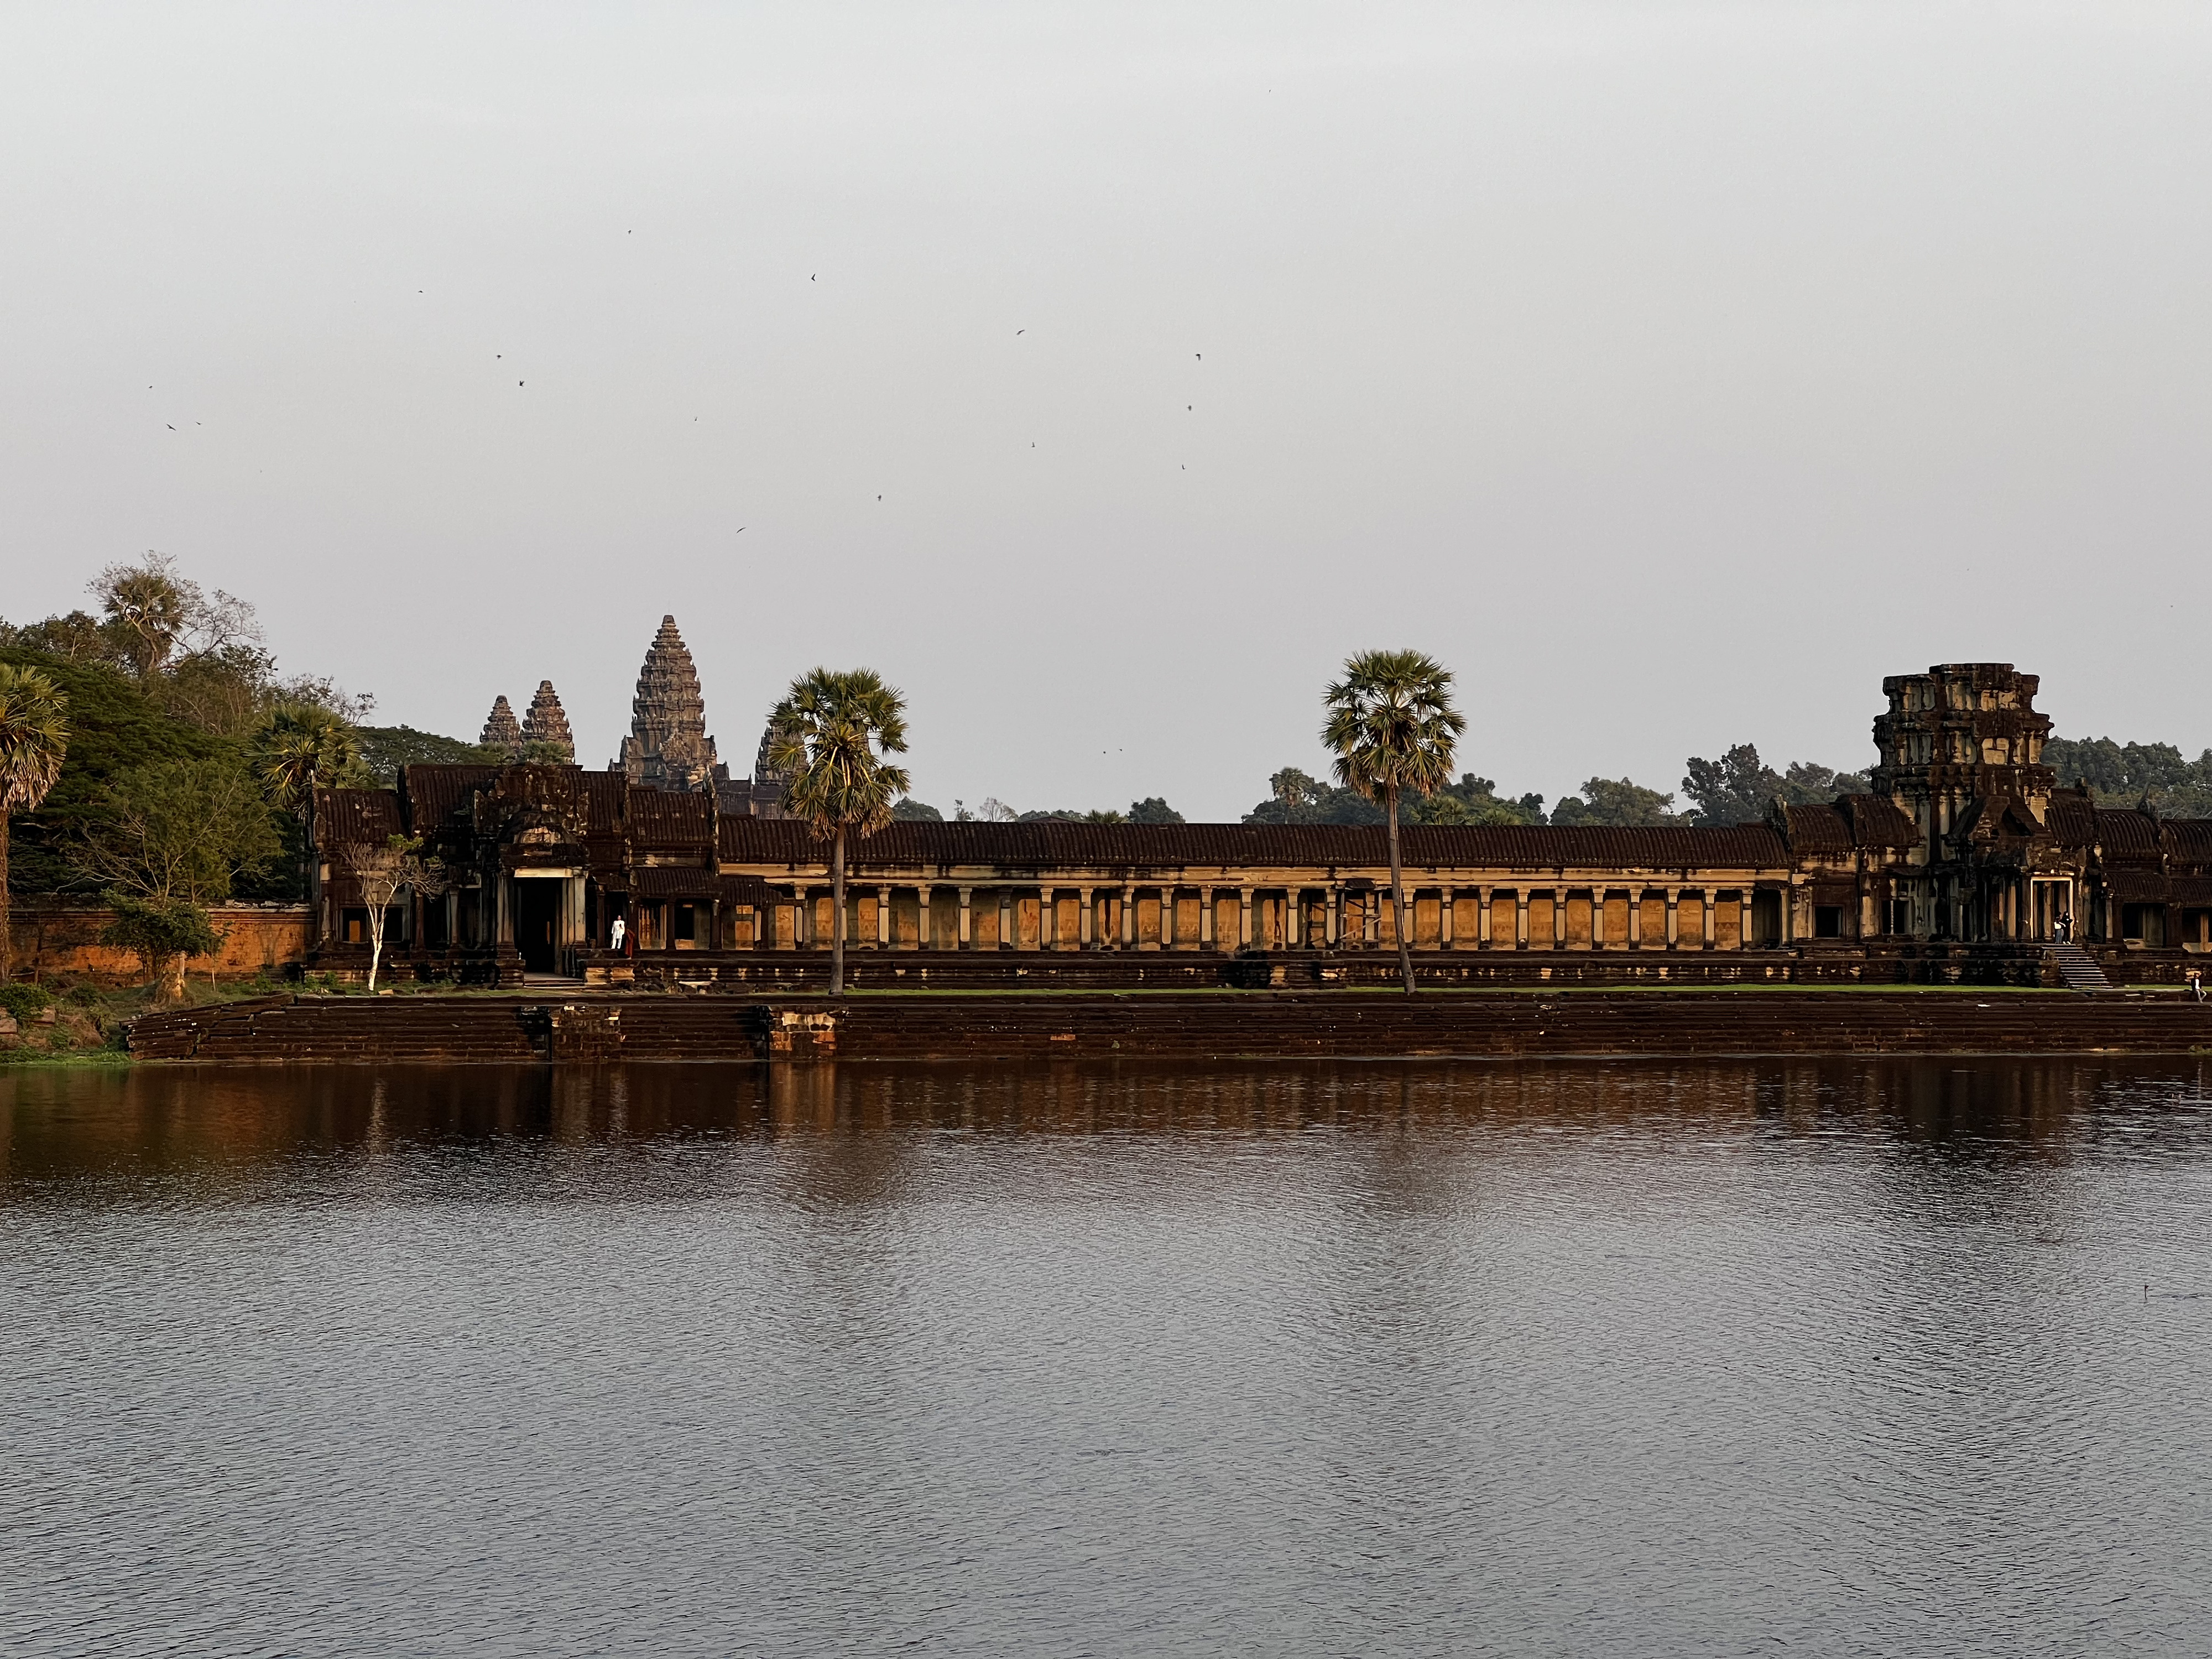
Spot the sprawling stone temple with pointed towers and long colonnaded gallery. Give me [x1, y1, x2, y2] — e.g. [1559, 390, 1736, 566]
[310, 664, 2212, 987]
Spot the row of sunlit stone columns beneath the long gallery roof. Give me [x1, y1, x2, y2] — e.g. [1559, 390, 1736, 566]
[757, 880, 1798, 951]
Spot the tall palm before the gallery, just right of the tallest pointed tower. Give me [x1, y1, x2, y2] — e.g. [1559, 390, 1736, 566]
[768, 668, 911, 998]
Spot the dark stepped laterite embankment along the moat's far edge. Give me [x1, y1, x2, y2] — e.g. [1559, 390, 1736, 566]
[131, 991, 2212, 1064]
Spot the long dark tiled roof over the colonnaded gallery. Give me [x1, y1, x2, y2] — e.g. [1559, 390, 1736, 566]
[721, 818, 1790, 872]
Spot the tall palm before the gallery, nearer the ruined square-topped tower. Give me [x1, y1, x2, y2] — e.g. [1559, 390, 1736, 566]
[1321, 650, 1467, 995]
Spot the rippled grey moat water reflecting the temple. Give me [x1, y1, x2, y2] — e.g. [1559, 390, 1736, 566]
[0, 1060, 2212, 1657]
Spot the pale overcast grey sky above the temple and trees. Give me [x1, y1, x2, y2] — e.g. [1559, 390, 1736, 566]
[0, 0, 2212, 816]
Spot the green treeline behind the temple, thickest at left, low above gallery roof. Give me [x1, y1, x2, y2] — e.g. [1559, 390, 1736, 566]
[0, 555, 2212, 905]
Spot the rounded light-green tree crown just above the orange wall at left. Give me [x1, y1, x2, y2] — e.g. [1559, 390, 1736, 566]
[75, 754, 279, 905]
